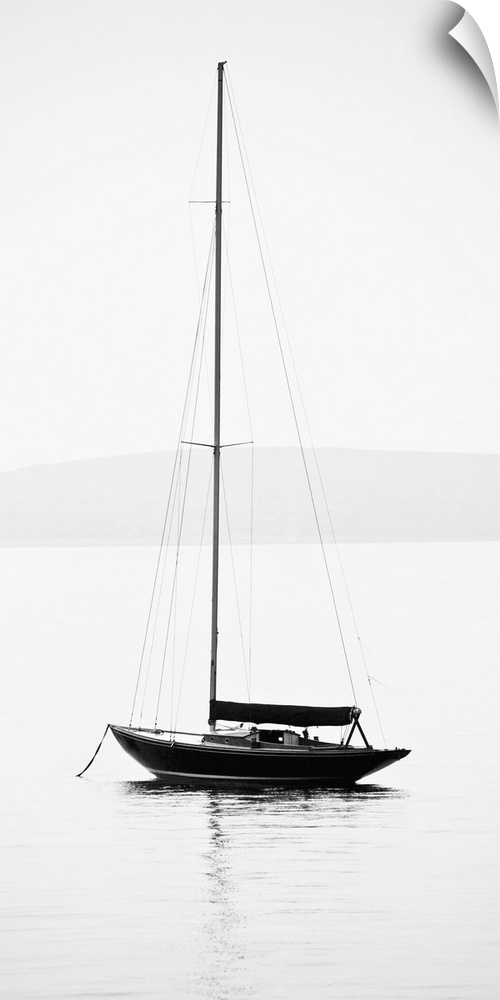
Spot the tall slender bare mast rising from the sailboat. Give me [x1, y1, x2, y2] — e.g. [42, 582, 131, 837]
[208, 62, 225, 730]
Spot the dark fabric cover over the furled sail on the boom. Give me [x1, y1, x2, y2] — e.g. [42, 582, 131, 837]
[210, 701, 354, 726]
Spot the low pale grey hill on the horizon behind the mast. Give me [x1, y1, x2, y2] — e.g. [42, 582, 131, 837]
[0, 448, 500, 546]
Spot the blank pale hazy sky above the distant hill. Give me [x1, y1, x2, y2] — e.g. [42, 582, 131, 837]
[0, 0, 500, 469]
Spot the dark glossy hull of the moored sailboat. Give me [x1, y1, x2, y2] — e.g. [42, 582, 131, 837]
[110, 726, 410, 788]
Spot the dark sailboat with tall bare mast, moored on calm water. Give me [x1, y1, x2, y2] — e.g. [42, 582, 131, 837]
[109, 62, 410, 787]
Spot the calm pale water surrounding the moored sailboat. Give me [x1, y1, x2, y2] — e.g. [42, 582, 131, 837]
[0, 544, 500, 1000]
